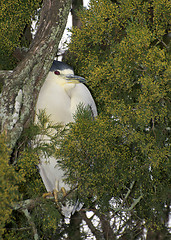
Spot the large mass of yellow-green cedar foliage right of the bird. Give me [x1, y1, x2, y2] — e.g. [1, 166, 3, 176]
[64, 0, 171, 232]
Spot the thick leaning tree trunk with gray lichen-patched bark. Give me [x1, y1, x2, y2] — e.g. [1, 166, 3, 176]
[0, 0, 71, 149]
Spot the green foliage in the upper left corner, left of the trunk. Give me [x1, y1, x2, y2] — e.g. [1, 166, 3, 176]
[0, 0, 41, 70]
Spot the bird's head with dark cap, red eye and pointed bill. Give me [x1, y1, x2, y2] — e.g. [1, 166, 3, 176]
[50, 61, 86, 89]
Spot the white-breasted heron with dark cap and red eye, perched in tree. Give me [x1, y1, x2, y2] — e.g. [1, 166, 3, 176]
[35, 60, 97, 217]
